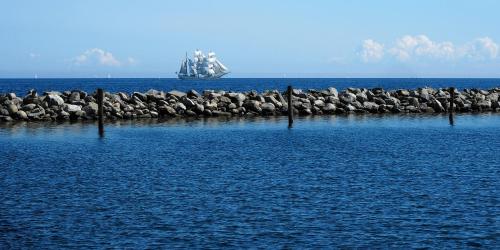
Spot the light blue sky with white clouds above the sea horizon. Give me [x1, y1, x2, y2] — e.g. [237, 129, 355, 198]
[0, 0, 500, 78]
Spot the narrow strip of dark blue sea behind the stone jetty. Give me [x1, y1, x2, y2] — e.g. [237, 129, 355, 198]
[0, 78, 500, 96]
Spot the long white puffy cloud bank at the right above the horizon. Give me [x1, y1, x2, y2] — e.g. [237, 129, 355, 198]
[359, 35, 498, 63]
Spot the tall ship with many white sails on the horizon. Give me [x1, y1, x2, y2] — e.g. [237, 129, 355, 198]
[176, 50, 229, 80]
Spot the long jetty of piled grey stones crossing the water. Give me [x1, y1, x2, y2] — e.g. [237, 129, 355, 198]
[0, 87, 500, 122]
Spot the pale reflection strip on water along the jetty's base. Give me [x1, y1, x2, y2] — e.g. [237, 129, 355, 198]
[0, 113, 500, 135]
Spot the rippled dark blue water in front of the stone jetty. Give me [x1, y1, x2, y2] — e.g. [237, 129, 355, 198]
[0, 114, 500, 249]
